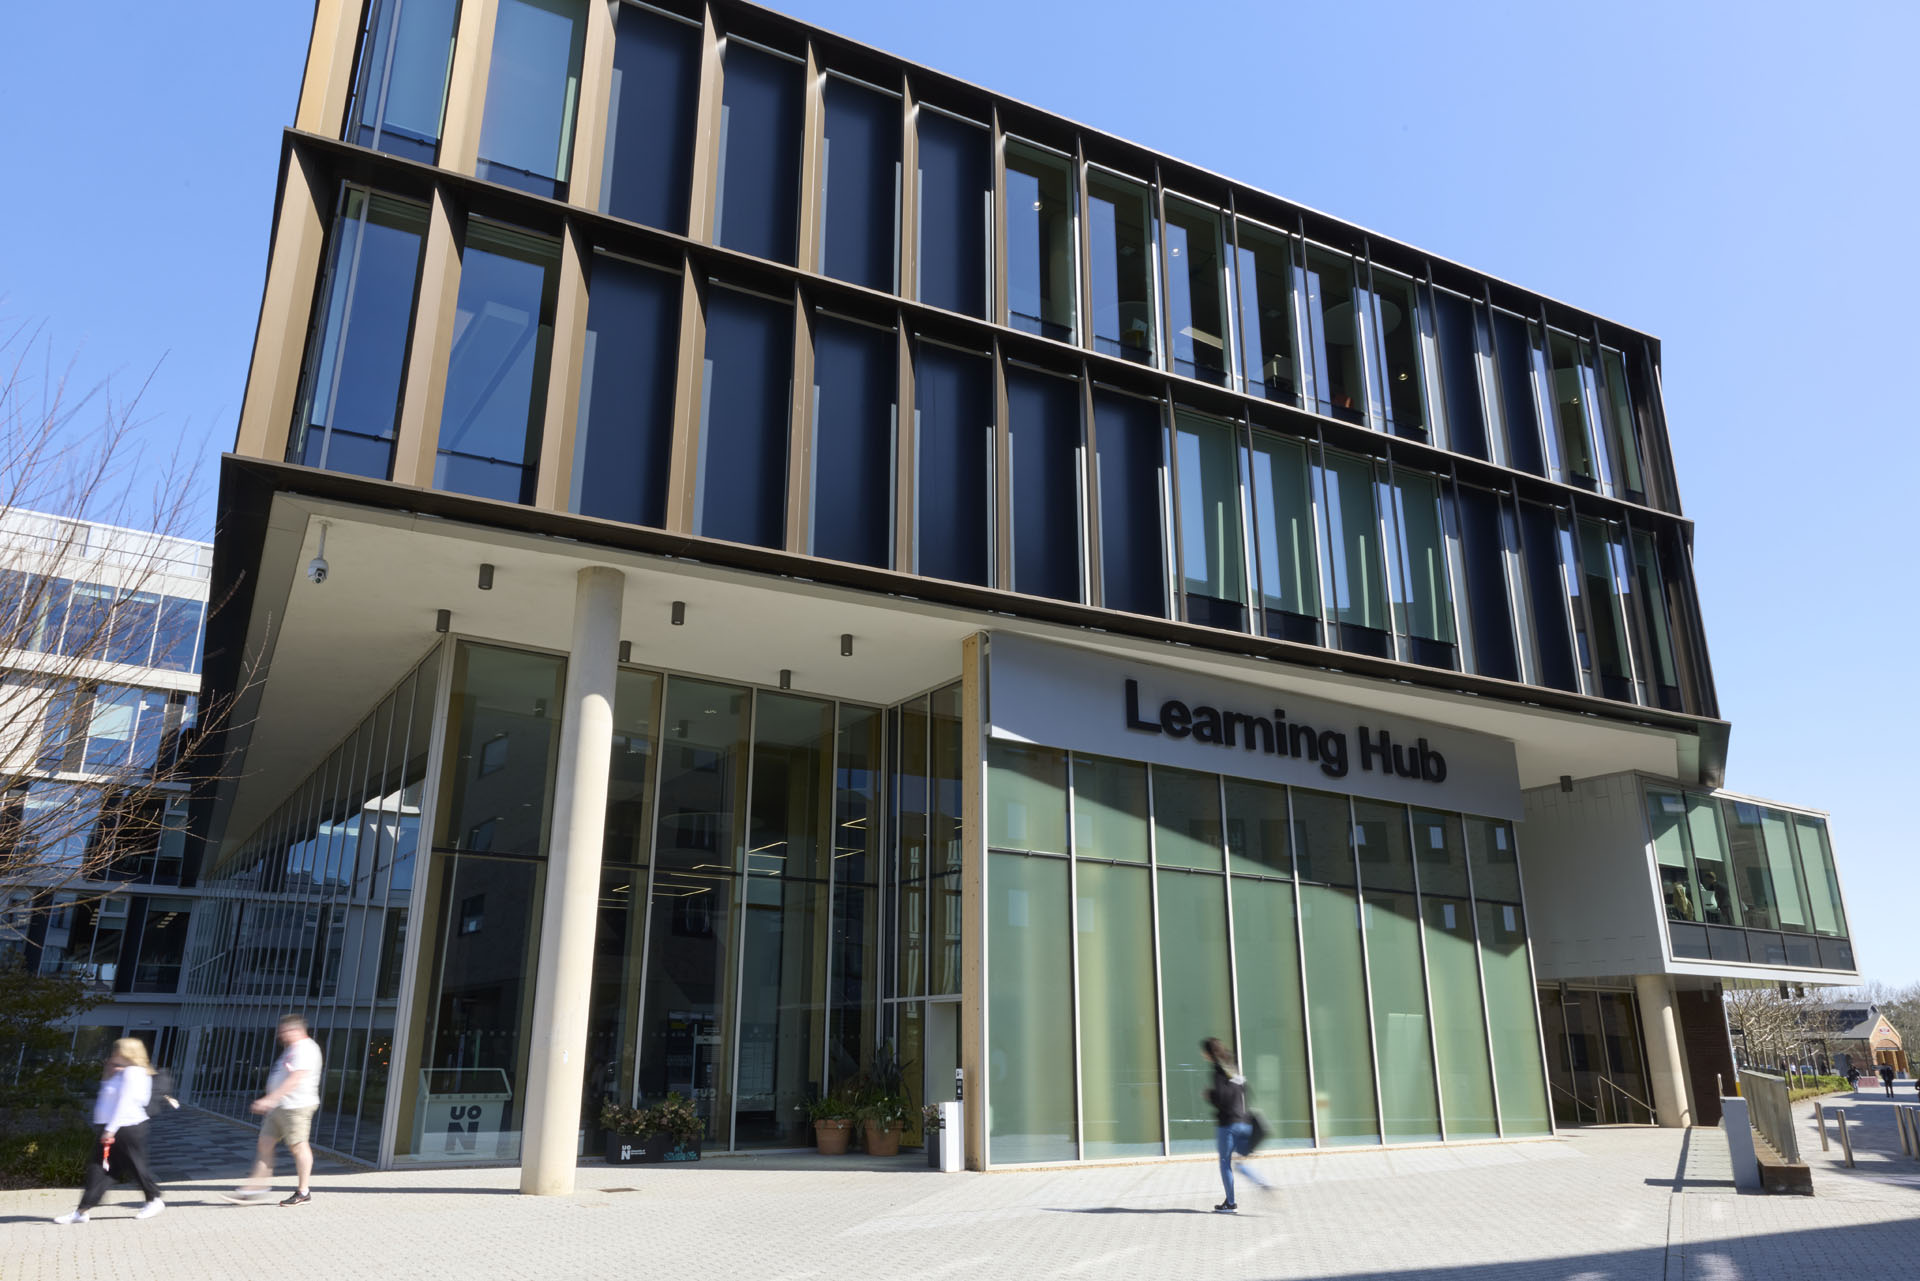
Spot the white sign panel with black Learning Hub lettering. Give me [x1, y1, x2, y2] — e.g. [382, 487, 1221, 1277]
[987, 632, 1521, 820]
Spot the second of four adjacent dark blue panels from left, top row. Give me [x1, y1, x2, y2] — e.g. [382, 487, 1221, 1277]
[714, 42, 806, 263]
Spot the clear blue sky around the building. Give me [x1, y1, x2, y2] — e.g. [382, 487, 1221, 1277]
[0, 0, 1920, 981]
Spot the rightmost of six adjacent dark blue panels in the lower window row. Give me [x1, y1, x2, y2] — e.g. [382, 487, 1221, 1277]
[1092, 390, 1167, 618]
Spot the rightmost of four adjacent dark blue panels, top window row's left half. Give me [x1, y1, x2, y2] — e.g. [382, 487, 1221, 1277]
[920, 111, 993, 317]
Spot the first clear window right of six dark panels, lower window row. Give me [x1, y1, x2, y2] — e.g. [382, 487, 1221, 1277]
[1175, 413, 1246, 632]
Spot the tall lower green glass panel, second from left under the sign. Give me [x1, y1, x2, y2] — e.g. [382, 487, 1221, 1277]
[1075, 868, 1160, 1158]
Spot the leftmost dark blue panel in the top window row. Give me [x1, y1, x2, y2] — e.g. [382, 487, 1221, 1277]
[601, 4, 701, 234]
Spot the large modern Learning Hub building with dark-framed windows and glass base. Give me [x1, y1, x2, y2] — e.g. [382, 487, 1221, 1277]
[192, 0, 1853, 1191]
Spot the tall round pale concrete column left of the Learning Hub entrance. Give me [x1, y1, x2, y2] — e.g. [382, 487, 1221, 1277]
[520, 567, 626, 1196]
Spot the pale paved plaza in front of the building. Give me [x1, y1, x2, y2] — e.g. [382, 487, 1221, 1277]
[0, 1091, 1920, 1281]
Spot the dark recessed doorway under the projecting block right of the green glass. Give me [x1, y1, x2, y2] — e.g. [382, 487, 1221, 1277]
[1540, 987, 1653, 1125]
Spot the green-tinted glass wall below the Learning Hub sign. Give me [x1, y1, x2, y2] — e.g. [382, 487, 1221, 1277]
[987, 739, 1549, 1164]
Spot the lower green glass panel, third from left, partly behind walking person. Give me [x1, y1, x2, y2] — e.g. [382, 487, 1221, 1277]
[1160, 872, 1235, 1152]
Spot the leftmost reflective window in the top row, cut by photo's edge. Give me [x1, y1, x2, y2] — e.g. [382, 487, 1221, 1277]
[348, 0, 459, 165]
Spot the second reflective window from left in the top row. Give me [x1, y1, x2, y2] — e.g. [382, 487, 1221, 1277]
[476, 0, 588, 196]
